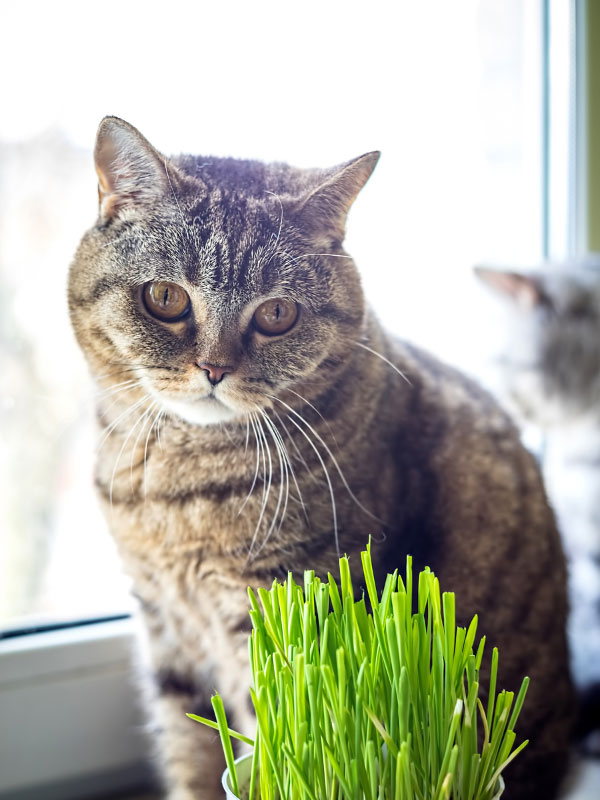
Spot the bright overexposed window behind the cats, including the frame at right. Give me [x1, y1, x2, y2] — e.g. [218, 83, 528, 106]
[0, 0, 600, 792]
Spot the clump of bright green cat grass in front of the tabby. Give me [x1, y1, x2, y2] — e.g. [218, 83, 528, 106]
[188, 545, 529, 800]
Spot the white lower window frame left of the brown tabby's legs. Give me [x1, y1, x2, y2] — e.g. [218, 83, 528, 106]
[0, 619, 157, 800]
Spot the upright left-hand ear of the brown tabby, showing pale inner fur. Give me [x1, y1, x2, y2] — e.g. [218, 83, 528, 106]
[94, 117, 168, 219]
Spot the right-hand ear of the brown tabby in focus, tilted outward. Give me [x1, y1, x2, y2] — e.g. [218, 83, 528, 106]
[297, 151, 381, 241]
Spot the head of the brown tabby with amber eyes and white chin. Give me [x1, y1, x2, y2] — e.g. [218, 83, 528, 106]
[69, 117, 379, 424]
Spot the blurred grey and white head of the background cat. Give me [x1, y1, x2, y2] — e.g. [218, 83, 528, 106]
[476, 262, 600, 427]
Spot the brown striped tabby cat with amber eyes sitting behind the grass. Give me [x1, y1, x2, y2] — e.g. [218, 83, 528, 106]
[69, 117, 572, 800]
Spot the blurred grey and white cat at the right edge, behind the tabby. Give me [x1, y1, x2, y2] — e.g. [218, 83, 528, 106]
[477, 266, 600, 748]
